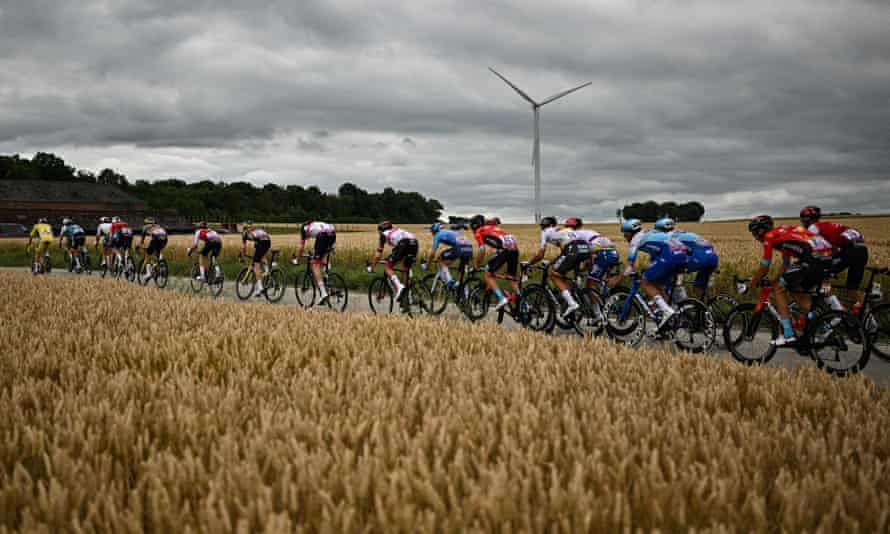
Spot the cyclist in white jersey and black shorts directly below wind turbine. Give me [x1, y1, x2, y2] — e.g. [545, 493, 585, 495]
[528, 217, 590, 317]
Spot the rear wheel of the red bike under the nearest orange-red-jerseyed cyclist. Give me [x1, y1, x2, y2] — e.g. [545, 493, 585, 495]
[804, 311, 869, 376]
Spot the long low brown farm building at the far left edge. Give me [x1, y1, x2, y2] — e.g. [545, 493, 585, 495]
[0, 180, 187, 231]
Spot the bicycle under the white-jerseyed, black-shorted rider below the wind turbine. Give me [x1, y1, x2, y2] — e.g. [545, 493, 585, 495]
[528, 261, 605, 336]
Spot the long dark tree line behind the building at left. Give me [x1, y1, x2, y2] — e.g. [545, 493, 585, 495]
[0, 152, 444, 223]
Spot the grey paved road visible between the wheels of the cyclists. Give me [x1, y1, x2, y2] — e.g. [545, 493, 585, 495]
[13, 268, 890, 386]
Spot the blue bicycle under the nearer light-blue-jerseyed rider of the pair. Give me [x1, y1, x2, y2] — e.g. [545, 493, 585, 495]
[604, 272, 717, 353]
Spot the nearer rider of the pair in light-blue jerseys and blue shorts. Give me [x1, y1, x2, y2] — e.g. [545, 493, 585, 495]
[618, 219, 686, 330]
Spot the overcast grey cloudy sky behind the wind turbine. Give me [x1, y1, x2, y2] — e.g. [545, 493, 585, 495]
[0, 0, 890, 221]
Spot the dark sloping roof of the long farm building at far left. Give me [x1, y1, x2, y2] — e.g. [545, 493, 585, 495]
[0, 180, 142, 204]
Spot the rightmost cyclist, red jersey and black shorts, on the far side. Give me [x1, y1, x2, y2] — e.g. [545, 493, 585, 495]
[800, 206, 868, 314]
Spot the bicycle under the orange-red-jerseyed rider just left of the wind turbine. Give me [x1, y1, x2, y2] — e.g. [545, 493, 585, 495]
[465, 262, 556, 332]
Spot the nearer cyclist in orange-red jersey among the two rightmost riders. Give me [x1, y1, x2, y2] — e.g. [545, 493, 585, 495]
[748, 215, 831, 346]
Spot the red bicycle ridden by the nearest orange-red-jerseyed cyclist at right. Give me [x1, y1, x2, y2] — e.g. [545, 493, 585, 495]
[723, 279, 870, 376]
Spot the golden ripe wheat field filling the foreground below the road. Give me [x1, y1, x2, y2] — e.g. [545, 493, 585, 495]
[0, 272, 890, 532]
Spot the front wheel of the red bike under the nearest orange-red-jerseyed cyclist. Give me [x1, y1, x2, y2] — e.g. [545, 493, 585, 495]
[723, 303, 780, 365]
